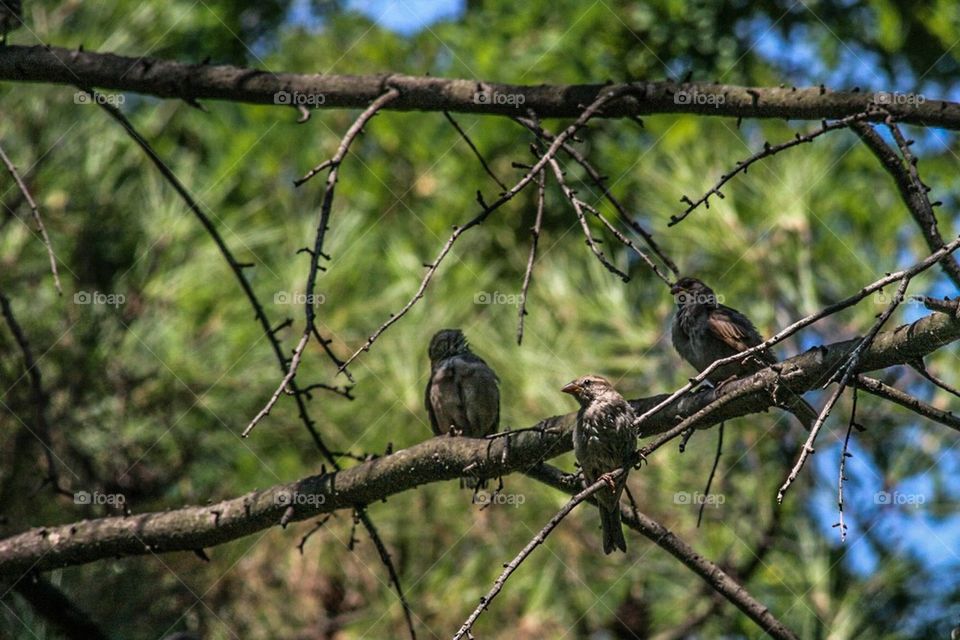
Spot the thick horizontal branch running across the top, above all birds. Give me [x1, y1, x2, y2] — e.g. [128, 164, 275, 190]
[0, 45, 960, 129]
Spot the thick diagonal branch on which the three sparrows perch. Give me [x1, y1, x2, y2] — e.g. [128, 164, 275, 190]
[0, 313, 960, 577]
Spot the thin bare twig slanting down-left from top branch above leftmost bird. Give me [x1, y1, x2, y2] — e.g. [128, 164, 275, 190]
[341, 88, 629, 369]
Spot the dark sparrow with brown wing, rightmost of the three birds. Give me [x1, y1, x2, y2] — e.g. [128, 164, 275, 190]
[670, 277, 818, 430]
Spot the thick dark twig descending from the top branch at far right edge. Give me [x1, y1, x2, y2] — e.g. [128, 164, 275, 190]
[851, 118, 960, 286]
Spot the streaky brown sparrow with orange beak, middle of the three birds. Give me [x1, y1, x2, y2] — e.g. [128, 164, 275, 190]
[561, 375, 637, 555]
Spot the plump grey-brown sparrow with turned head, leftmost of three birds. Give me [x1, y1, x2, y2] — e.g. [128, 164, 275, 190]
[424, 329, 500, 438]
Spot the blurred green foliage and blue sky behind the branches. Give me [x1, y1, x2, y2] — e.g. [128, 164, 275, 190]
[0, 0, 960, 640]
